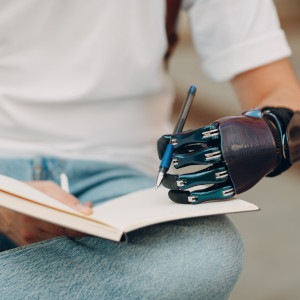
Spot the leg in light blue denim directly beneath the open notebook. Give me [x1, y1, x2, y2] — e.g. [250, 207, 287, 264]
[0, 216, 243, 300]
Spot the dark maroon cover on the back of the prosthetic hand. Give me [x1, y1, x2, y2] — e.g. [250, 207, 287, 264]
[216, 115, 277, 194]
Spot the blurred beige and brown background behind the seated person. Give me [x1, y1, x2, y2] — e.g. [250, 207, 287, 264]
[169, 0, 300, 300]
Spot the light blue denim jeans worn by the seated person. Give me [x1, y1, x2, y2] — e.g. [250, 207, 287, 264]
[0, 158, 243, 300]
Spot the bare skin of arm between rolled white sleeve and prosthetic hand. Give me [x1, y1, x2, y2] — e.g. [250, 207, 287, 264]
[231, 59, 300, 111]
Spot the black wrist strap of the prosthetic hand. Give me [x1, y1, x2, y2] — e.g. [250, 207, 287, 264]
[262, 107, 294, 177]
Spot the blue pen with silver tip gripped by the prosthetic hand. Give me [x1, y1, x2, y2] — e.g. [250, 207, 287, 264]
[155, 85, 197, 190]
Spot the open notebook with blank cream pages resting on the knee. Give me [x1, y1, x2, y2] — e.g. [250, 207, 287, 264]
[0, 175, 259, 241]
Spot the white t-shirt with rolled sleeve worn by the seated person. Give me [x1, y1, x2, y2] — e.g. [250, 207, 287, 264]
[0, 0, 290, 174]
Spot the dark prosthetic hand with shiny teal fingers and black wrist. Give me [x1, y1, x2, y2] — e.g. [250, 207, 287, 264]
[157, 108, 300, 204]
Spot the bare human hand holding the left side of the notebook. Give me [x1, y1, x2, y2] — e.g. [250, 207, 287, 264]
[0, 181, 92, 246]
